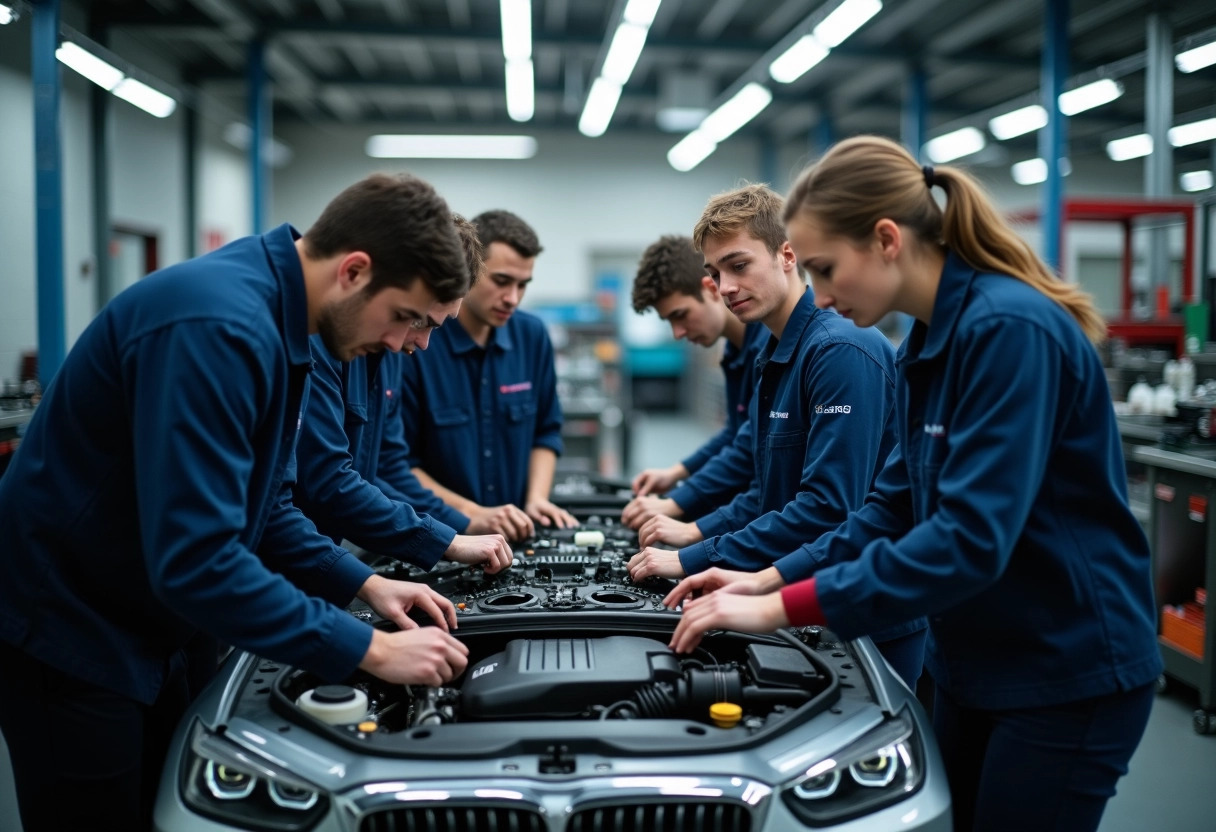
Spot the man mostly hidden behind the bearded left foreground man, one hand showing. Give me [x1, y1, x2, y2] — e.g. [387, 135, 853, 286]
[292, 217, 511, 573]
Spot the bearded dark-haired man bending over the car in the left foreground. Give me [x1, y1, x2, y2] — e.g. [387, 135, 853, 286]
[0, 175, 483, 832]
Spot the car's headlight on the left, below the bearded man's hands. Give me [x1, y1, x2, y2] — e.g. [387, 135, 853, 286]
[180, 726, 330, 832]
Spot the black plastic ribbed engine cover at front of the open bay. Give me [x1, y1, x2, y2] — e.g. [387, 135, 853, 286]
[461, 636, 681, 719]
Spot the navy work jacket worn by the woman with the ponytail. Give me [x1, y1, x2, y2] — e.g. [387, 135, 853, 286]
[776, 254, 1161, 708]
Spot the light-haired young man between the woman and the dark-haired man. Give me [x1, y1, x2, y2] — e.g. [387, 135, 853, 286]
[629, 185, 925, 688]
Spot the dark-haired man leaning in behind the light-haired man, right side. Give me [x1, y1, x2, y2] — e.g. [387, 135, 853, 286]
[621, 235, 769, 529]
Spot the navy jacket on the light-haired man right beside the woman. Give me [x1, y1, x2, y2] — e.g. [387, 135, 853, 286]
[680, 292, 895, 574]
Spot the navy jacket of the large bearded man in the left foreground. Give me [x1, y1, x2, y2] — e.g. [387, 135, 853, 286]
[0, 225, 372, 703]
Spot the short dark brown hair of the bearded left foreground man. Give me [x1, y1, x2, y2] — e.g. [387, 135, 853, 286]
[304, 174, 469, 303]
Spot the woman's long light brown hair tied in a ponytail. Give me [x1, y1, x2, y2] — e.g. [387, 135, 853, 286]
[784, 136, 1107, 343]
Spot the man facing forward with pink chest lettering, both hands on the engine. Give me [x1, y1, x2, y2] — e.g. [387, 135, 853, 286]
[401, 210, 575, 532]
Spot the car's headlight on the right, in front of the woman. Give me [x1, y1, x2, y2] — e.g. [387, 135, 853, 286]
[782, 716, 924, 826]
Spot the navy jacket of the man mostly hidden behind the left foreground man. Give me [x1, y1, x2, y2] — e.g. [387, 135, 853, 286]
[293, 336, 467, 569]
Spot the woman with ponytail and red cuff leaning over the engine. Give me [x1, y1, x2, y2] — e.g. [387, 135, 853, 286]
[668, 136, 1161, 832]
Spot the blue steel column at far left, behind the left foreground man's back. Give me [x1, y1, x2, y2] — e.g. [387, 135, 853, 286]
[30, 0, 67, 388]
